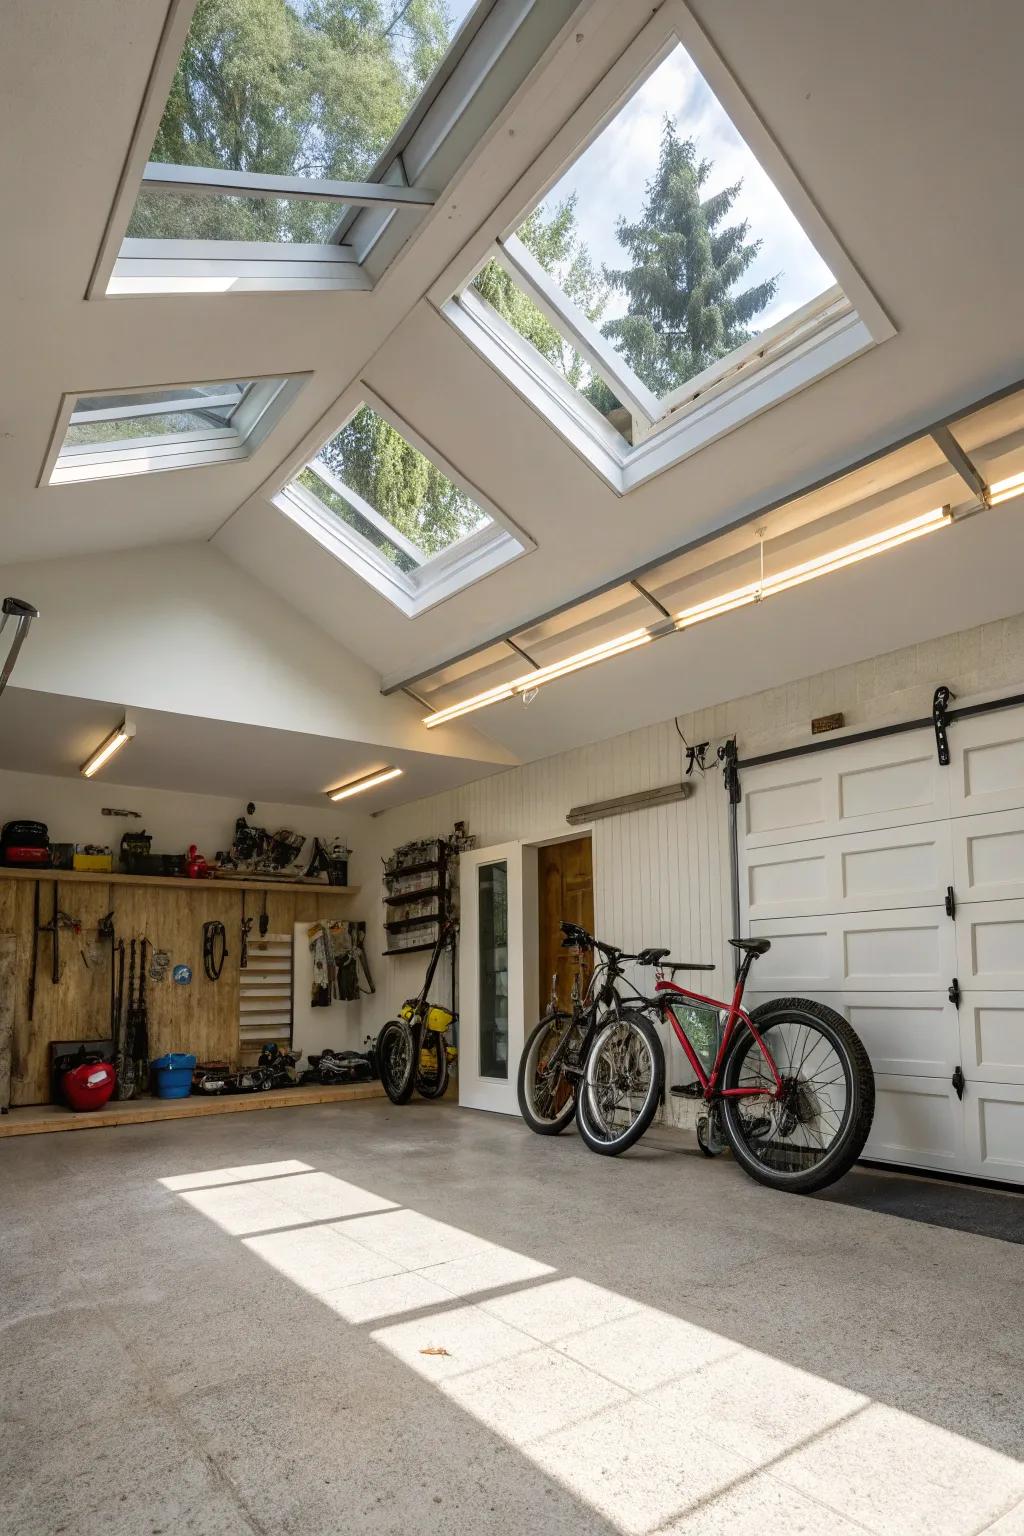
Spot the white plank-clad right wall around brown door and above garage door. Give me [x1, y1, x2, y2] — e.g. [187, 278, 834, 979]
[365, 614, 1024, 1123]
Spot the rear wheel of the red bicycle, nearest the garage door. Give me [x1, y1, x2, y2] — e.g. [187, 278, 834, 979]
[722, 997, 875, 1193]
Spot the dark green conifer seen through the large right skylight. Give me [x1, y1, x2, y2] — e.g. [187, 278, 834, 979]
[593, 118, 778, 398]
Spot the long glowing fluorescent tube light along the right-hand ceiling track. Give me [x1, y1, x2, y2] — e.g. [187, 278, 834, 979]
[424, 500, 951, 730]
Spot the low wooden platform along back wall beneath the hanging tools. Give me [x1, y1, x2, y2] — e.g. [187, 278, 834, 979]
[0, 1083, 384, 1138]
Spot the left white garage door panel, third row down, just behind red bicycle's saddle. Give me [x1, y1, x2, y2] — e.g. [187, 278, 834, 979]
[749, 908, 956, 995]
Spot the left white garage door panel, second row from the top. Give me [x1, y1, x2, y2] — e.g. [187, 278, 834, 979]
[743, 822, 952, 922]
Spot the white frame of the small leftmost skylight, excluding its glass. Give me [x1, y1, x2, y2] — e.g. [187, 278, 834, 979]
[38, 373, 309, 487]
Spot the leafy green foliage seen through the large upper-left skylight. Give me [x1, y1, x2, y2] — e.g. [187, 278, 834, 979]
[129, 0, 451, 241]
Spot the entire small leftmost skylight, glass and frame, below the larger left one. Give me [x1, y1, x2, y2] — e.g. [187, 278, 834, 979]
[43, 378, 301, 485]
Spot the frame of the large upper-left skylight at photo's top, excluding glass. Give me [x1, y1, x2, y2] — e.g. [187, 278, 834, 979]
[86, 0, 576, 300]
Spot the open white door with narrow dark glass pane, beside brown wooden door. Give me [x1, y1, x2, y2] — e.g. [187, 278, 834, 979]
[459, 843, 537, 1115]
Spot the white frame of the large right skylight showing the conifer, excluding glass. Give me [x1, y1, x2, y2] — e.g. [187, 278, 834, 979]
[430, 0, 895, 495]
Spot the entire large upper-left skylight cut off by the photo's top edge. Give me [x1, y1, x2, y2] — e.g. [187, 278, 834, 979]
[91, 0, 570, 295]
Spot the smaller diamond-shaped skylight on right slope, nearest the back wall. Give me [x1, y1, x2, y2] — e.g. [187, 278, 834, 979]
[275, 402, 531, 617]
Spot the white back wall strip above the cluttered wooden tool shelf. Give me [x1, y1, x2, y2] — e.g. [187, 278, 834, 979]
[0, 771, 376, 884]
